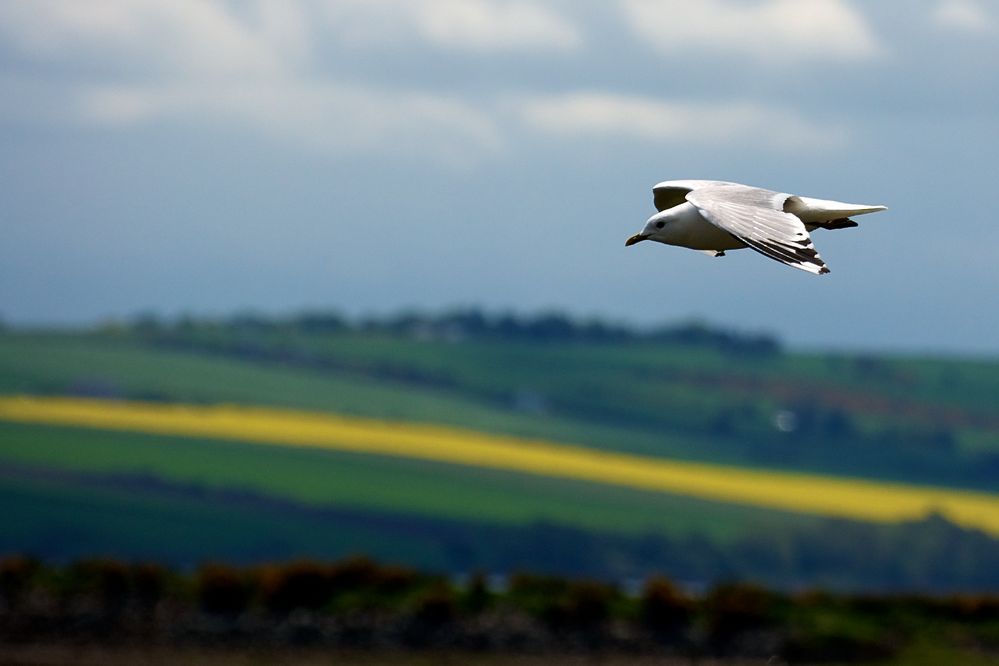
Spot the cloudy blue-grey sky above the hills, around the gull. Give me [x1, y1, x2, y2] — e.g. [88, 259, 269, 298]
[0, 0, 999, 356]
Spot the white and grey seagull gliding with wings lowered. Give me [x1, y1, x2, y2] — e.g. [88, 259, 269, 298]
[625, 180, 887, 275]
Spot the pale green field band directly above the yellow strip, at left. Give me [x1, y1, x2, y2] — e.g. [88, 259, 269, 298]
[0, 334, 709, 458]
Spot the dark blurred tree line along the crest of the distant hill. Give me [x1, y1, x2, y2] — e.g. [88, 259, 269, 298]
[121, 307, 782, 355]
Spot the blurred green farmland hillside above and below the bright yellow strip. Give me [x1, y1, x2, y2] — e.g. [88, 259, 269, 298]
[0, 311, 999, 589]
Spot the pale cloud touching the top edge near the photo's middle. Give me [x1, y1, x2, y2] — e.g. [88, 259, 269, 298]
[322, 0, 582, 53]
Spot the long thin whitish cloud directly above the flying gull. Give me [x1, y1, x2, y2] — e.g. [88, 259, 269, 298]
[520, 93, 848, 151]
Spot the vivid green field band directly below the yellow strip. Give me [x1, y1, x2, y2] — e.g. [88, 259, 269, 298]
[0, 423, 809, 537]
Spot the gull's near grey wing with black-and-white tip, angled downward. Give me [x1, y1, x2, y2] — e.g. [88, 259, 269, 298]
[686, 185, 829, 275]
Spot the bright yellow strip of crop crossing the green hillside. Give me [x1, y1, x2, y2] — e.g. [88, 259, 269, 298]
[0, 397, 999, 535]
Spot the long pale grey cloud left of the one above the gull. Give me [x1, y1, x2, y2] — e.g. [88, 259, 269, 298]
[77, 80, 502, 164]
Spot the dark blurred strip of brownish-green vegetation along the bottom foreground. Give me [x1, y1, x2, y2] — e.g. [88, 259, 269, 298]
[0, 557, 999, 662]
